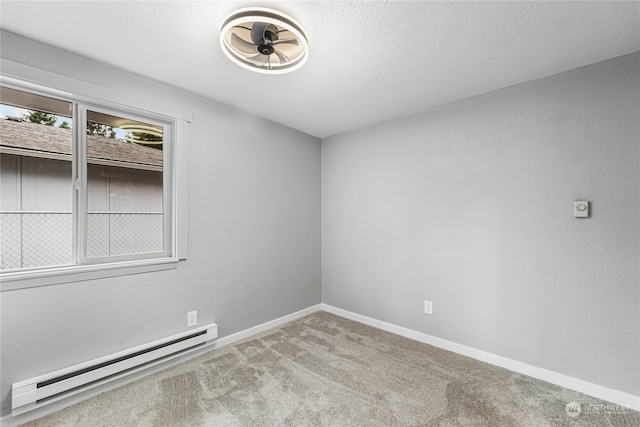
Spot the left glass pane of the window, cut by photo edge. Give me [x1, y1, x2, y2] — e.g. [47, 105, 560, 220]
[0, 87, 73, 271]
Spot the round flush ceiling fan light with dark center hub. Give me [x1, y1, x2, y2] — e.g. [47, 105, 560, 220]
[220, 8, 309, 74]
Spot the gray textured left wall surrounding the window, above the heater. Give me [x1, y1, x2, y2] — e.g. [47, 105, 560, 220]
[0, 31, 320, 415]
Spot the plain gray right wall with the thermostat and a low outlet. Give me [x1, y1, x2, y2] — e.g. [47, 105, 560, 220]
[322, 53, 640, 395]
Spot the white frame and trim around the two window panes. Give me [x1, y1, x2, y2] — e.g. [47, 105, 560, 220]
[0, 59, 191, 292]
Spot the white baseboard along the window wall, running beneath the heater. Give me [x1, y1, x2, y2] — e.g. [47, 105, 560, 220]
[0, 304, 322, 427]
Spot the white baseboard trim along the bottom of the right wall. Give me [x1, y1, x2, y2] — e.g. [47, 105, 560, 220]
[322, 304, 640, 411]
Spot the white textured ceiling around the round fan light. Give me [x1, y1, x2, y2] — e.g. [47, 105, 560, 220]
[0, 1, 640, 137]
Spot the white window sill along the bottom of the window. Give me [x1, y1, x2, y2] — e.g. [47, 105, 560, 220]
[0, 258, 178, 292]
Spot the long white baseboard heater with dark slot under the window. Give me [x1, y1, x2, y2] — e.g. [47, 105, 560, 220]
[11, 323, 218, 416]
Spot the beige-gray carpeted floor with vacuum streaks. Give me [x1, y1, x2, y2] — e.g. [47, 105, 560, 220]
[21, 312, 640, 427]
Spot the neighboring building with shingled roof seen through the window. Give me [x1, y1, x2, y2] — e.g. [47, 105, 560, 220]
[0, 120, 163, 270]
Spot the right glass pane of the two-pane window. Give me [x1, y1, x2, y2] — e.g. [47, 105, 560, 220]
[87, 111, 164, 258]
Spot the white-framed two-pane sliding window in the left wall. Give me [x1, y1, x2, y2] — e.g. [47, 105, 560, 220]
[0, 80, 185, 290]
